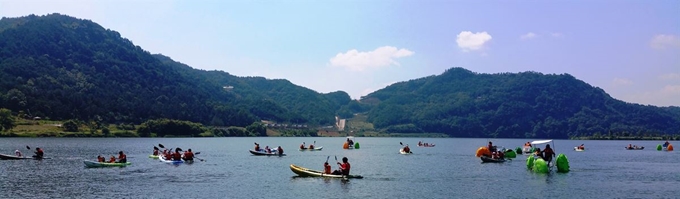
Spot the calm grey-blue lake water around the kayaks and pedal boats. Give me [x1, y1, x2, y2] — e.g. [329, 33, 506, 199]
[0, 137, 680, 198]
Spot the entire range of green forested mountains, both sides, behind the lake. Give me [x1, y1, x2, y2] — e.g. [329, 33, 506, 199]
[0, 14, 680, 138]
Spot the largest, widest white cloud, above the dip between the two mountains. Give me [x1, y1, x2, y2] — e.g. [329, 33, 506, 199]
[330, 46, 414, 71]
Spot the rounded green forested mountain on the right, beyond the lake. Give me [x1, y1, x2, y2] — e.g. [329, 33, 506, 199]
[361, 68, 680, 138]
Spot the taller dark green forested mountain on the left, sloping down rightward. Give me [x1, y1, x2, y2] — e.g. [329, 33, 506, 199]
[0, 14, 350, 126]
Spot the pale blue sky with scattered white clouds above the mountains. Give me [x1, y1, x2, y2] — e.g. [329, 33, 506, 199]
[0, 0, 680, 106]
